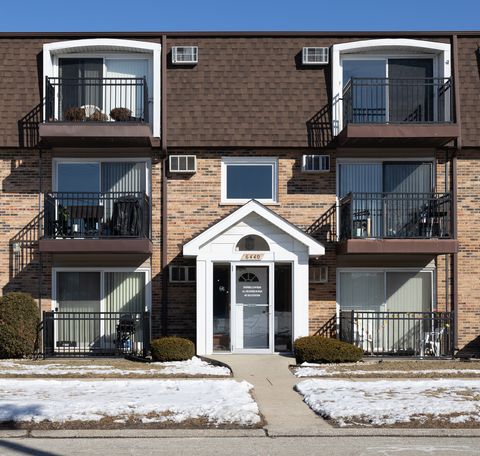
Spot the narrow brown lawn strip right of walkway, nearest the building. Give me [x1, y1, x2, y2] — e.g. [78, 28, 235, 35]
[292, 360, 480, 378]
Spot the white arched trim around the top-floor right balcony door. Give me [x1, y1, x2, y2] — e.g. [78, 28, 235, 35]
[332, 38, 451, 136]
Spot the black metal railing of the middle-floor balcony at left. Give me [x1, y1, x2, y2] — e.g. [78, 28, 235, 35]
[44, 192, 151, 239]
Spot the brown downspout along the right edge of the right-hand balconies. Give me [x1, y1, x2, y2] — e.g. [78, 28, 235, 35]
[452, 35, 462, 351]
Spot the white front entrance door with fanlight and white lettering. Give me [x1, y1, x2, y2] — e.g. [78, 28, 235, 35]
[233, 265, 272, 352]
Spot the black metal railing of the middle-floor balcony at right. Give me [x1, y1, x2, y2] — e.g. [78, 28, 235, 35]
[339, 193, 452, 240]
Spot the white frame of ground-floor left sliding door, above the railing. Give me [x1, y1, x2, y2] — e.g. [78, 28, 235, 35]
[51, 267, 152, 312]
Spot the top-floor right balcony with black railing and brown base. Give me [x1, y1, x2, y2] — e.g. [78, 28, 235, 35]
[338, 78, 459, 147]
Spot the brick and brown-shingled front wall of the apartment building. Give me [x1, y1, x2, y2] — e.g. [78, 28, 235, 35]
[0, 33, 480, 349]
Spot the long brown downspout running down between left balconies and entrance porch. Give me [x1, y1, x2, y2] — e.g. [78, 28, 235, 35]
[160, 35, 168, 336]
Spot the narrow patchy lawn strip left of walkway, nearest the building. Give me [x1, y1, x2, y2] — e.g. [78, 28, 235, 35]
[0, 357, 231, 378]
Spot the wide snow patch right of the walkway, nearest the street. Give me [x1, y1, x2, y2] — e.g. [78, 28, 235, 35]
[296, 379, 480, 426]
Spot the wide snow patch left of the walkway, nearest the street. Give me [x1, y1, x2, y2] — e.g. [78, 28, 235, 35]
[0, 379, 260, 425]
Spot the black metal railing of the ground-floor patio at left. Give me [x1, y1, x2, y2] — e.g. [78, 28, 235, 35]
[40, 312, 150, 358]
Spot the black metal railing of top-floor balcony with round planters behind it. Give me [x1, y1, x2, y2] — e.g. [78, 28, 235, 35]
[45, 77, 149, 123]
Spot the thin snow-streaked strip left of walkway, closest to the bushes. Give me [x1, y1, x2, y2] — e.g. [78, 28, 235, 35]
[0, 357, 230, 377]
